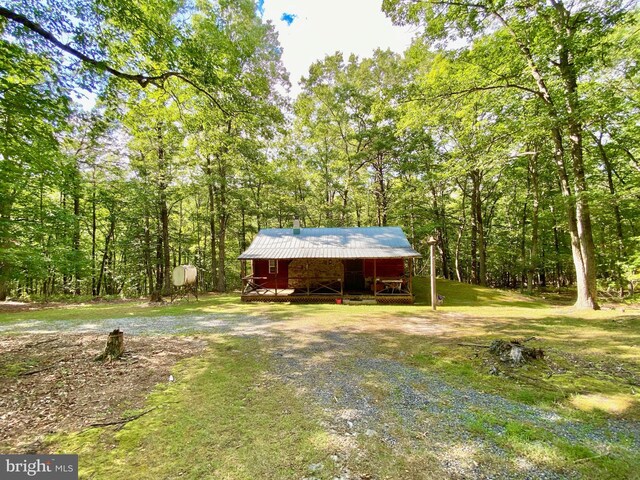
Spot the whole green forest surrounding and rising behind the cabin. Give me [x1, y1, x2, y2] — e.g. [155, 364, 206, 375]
[0, 0, 640, 309]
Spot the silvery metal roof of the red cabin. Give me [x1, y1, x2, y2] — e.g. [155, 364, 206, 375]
[238, 227, 421, 260]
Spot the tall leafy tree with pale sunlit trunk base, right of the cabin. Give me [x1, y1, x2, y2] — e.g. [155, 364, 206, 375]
[383, 0, 625, 309]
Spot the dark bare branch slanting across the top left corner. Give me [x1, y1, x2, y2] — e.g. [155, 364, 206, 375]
[0, 7, 229, 115]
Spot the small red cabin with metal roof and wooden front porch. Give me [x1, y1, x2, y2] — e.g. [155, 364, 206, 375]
[239, 224, 421, 304]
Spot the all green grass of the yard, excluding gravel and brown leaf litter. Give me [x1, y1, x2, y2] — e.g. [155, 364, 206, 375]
[7, 279, 640, 479]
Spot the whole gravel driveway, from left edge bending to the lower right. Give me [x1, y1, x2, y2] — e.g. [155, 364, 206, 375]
[0, 313, 640, 479]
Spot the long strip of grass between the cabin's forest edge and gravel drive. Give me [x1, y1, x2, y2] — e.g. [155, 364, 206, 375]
[0, 277, 632, 323]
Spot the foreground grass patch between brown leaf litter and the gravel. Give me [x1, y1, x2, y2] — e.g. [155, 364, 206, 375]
[49, 339, 335, 479]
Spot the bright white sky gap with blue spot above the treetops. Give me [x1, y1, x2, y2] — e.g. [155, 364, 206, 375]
[257, 0, 415, 97]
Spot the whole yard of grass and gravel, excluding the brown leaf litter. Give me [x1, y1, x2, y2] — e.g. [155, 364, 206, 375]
[0, 279, 640, 479]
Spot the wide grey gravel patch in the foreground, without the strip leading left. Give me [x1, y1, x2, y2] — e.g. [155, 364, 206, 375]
[274, 332, 640, 479]
